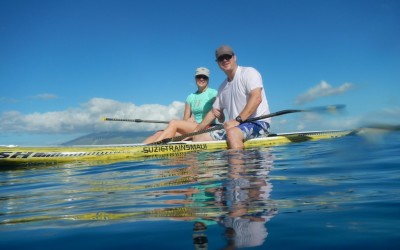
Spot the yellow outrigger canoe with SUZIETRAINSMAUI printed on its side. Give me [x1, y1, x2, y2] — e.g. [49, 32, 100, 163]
[0, 130, 354, 166]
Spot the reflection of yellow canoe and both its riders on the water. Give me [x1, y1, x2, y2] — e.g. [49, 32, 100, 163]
[0, 149, 277, 249]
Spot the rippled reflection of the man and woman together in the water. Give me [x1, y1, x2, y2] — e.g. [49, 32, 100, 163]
[176, 150, 277, 249]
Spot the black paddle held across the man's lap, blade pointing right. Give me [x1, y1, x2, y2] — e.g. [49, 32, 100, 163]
[150, 104, 346, 145]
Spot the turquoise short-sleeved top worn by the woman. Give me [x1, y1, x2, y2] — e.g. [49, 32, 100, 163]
[186, 88, 218, 123]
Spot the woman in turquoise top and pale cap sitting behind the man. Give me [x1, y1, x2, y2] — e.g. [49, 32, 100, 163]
[143, 67, 222, 144]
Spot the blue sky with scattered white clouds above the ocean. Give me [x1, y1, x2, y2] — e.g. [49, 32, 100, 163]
[0, 0, 400, 145]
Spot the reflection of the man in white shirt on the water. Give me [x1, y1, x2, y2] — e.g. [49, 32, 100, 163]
[214, 150, 277, 249]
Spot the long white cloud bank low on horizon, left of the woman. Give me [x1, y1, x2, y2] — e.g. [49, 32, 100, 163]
[0, 98, 185, 134]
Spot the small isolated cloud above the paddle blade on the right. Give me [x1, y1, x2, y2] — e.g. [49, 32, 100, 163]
[295, 81, 353, 105]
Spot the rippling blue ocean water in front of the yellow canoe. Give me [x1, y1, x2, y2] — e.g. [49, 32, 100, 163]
[0, 132, 400, 250]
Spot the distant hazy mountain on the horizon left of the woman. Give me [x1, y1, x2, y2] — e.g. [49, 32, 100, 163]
[61, 131, 154, 146]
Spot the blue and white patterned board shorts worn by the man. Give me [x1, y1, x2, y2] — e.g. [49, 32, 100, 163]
[210, 121, 270, 141]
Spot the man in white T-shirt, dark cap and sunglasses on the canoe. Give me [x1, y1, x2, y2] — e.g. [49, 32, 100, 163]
[194, 45, 270, 149]
